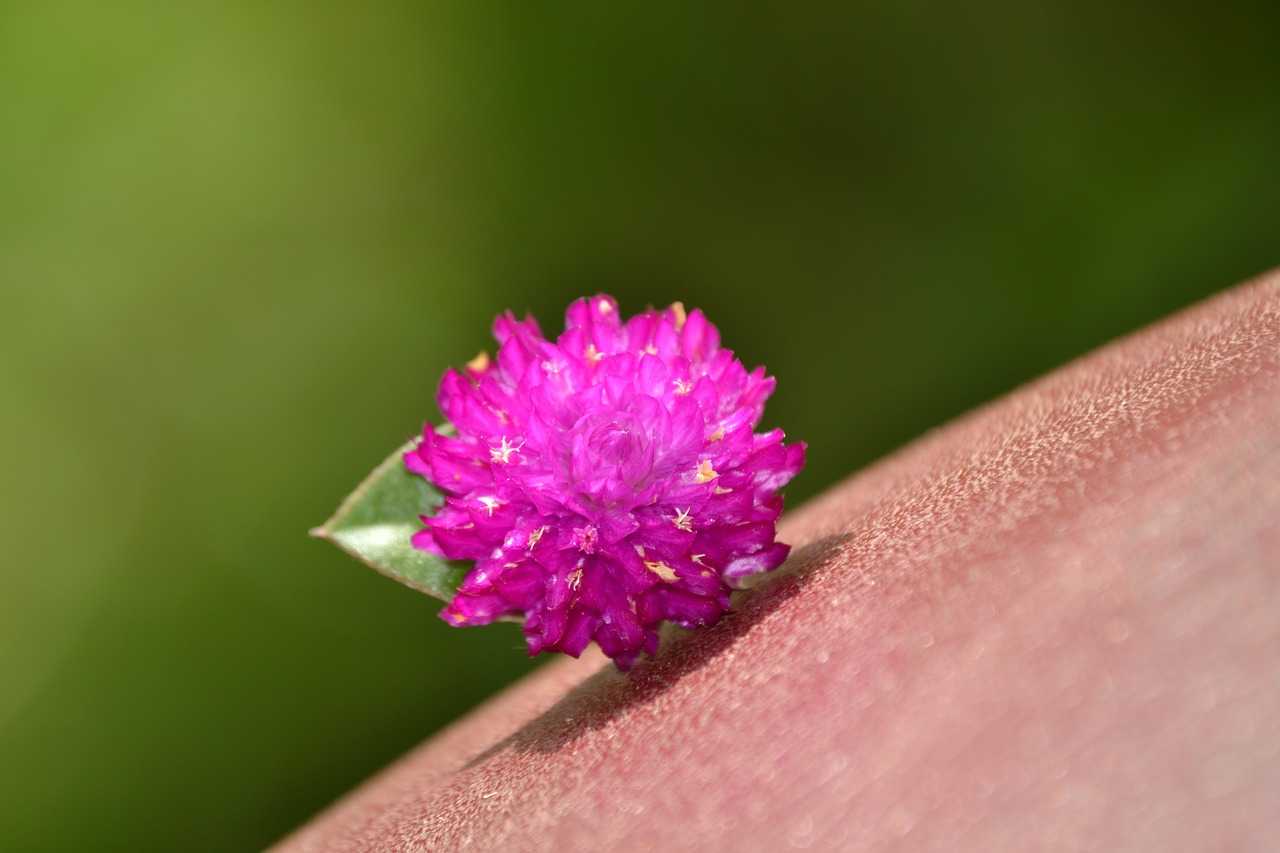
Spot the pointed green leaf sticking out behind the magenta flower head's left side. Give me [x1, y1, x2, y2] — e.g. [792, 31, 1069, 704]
[311, 439, 471, 601]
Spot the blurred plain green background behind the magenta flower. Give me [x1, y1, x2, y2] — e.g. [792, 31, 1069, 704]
[0, 0, 1280, 850]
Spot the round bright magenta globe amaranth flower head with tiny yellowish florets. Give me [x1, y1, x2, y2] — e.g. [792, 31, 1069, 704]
[404, 296, 805, 670]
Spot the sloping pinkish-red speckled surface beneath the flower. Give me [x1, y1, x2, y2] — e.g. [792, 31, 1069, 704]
[275, 273, 1280, 853]
